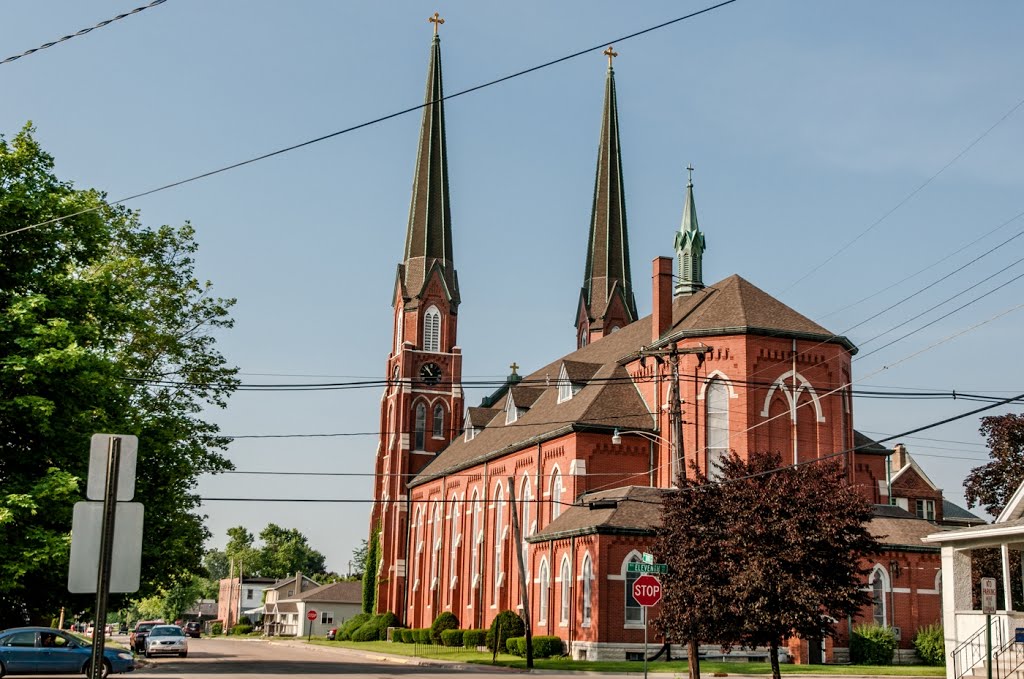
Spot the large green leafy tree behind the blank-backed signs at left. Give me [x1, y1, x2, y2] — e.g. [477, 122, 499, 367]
[0, 126, 238, 627]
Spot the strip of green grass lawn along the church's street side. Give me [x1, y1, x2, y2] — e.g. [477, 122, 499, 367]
[311, 639, 945, 677]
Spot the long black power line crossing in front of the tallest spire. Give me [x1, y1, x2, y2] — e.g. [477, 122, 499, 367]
[0, 0, 737, 238]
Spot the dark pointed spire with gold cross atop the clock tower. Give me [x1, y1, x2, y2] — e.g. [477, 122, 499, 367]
[402, 13, 459, 305]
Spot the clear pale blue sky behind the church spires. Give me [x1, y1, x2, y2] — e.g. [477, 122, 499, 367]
[0, 0, 1024, 571]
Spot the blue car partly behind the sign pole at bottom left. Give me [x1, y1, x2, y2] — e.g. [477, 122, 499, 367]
[0, 627, 135, 677]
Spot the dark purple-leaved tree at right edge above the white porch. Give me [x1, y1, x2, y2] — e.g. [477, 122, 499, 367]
[964, 413, 1024, 514]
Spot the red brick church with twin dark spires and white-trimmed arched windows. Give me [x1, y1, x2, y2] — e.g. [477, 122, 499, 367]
[371, 25, 980, 662]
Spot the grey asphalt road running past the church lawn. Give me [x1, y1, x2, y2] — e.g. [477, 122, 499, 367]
[132, 638, 520, 679]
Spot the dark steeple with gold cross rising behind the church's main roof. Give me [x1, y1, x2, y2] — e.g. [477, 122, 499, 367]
[575, 47, 637, 346]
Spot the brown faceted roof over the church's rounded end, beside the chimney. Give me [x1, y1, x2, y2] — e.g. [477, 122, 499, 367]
[657, 274, 857, 353]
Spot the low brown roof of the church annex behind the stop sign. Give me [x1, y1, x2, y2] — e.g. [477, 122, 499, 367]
[527, 485, 668, 543]
